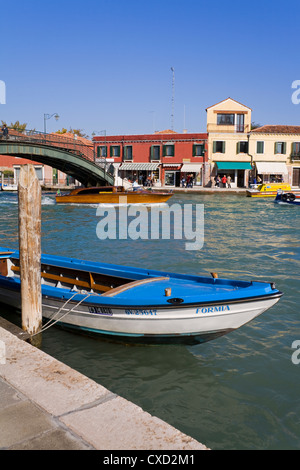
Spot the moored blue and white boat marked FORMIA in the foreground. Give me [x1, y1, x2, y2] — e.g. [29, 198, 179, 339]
[0, 248, 282, 342]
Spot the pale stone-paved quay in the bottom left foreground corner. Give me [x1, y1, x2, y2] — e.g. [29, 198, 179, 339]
[0, 318, 208, 451]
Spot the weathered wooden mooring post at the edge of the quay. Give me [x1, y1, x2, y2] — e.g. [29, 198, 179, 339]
[18, 165, 42, 347]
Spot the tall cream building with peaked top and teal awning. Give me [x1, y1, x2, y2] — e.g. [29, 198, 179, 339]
[206, 98, 252, 188]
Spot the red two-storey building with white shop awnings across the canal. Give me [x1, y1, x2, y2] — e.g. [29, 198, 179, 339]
[93, 130, 209, 187]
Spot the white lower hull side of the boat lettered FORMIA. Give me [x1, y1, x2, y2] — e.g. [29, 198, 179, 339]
[0, 278, 280, 343]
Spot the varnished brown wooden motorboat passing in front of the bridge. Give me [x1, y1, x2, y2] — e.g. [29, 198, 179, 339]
[56, 186, 173, 204]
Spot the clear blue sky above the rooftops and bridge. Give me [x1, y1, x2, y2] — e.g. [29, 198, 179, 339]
[0, 0, 300, 135]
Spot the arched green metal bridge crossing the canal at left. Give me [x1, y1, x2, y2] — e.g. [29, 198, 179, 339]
[0, 129, 114, 186]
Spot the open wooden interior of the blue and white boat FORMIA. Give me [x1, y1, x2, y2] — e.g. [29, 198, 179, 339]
[0, 252, 169, 297]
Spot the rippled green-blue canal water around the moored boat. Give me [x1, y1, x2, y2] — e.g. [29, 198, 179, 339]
[0, 193, 300, 449]
